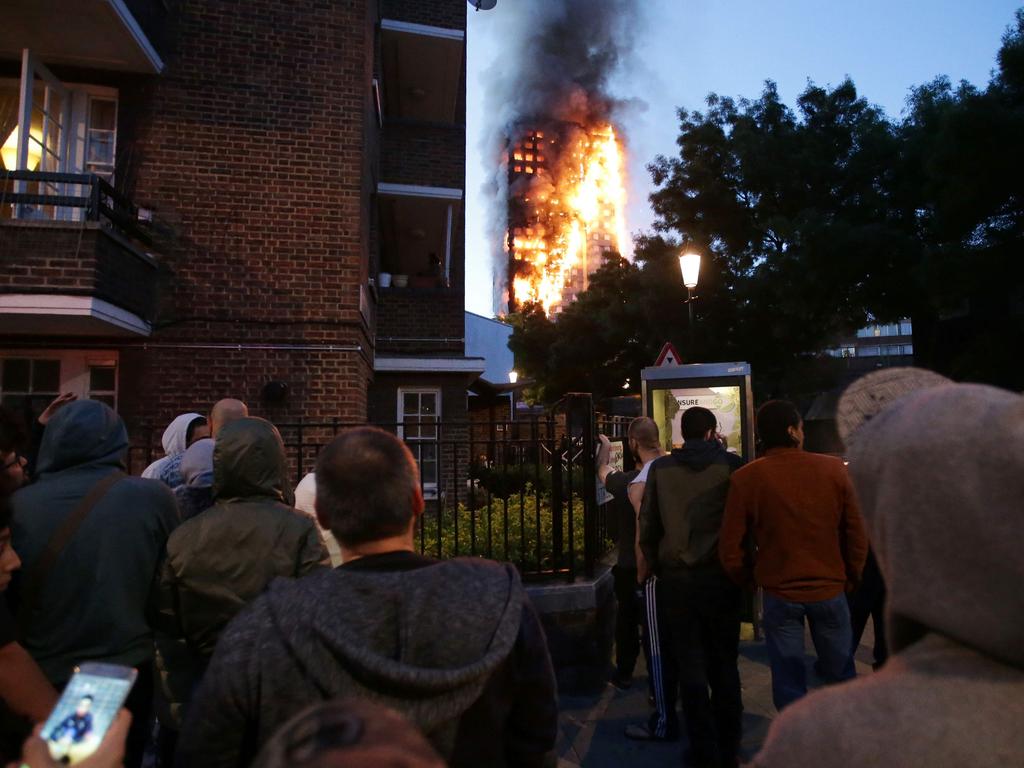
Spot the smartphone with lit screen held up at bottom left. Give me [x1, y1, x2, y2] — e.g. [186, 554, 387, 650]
[40, 663, 138, 765]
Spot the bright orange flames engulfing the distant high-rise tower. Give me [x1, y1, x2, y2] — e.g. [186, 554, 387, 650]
[509, 125, 628, 314]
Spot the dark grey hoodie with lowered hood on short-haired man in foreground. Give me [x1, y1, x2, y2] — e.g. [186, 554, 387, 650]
[178, 553, 558, 768]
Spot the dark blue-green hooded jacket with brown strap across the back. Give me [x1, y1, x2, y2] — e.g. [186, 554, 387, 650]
[11, 400, 177, 687]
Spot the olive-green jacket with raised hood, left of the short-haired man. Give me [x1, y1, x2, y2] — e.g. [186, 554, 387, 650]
[157, 418, 327, 723]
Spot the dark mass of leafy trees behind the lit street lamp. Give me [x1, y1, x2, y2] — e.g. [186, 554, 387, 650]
[512, 10, 1024, 400]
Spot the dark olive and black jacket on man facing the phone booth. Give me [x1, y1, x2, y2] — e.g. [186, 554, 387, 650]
[639, 439, 743, 573]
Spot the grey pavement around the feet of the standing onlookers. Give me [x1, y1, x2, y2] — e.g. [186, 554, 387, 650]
[556, 622, 874, 768]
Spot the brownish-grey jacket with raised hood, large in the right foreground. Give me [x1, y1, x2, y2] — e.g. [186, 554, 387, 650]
[755, 384, 1024, 768]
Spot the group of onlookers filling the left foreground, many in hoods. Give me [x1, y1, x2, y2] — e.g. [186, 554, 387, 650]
[0, 396, 558, 768]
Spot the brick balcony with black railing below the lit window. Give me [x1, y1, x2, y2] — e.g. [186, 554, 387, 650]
[0, 171, 158, 336]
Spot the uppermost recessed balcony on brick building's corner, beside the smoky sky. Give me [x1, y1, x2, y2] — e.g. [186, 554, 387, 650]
[381, 18, 466, 124]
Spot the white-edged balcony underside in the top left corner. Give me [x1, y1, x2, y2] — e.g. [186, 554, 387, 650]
[0, 0, 166, 75]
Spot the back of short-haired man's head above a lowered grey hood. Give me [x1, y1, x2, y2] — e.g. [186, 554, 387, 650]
[316, 427, 420, 546]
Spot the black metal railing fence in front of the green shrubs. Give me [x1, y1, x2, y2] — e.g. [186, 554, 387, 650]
[132, 395, 629, 582]
